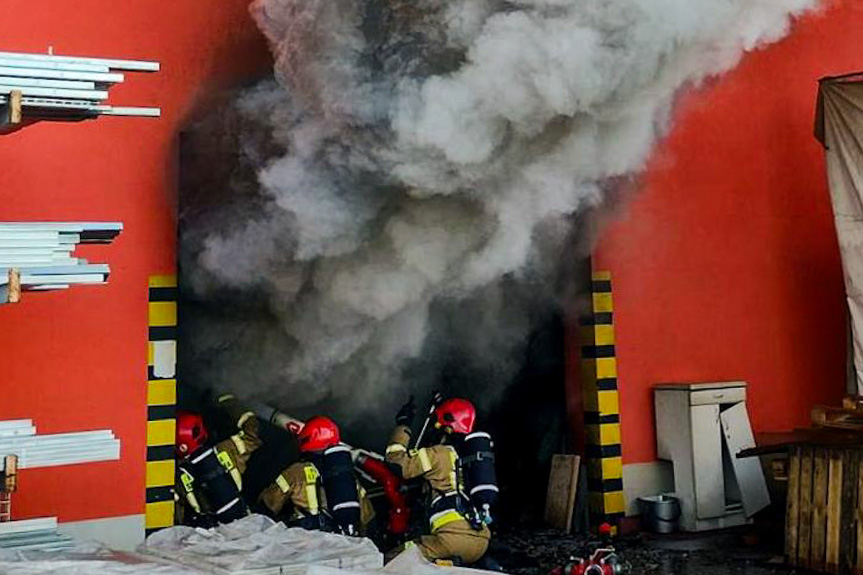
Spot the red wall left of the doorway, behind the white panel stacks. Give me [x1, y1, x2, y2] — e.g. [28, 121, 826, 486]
[0, 0, 268, 520]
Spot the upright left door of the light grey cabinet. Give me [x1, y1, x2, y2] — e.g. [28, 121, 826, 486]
[689, 404, 725, 519]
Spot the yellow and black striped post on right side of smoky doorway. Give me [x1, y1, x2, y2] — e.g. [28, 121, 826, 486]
[580, 271, 626, 525]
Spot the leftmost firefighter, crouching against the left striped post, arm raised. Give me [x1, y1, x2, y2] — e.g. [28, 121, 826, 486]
[175, 394, 262, 526]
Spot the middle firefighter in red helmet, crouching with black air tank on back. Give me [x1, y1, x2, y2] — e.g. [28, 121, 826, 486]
[259, 416, 373, 535]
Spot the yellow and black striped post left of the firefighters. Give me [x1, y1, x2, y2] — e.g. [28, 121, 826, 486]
[145, 276, 177, 534]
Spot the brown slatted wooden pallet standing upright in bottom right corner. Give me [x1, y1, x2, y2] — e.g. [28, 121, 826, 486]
[785, 446, 863, 575]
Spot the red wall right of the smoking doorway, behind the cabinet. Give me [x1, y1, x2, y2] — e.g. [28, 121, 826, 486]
[594, 0, 863, 463]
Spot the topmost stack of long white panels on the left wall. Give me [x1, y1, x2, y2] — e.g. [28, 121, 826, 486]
[0, 52, 161, 120]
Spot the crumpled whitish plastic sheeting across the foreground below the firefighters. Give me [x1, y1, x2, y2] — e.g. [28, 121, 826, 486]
[0, 515, 502, 575]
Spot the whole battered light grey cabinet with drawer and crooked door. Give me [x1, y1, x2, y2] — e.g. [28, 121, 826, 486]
[654, 381, 770, 531]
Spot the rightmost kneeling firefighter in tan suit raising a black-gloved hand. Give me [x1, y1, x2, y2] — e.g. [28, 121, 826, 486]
[386, 399, 491, 564]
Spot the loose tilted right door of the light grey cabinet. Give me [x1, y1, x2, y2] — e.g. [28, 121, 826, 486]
[720, 403, 770, 517]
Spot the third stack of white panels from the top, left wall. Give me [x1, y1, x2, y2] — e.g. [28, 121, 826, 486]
[0, 419, 120, 471]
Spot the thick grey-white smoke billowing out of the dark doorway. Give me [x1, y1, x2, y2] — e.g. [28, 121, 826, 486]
[183, 0, 816, 424]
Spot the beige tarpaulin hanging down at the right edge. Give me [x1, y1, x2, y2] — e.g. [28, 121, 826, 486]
[815, 74, 863, 394]
